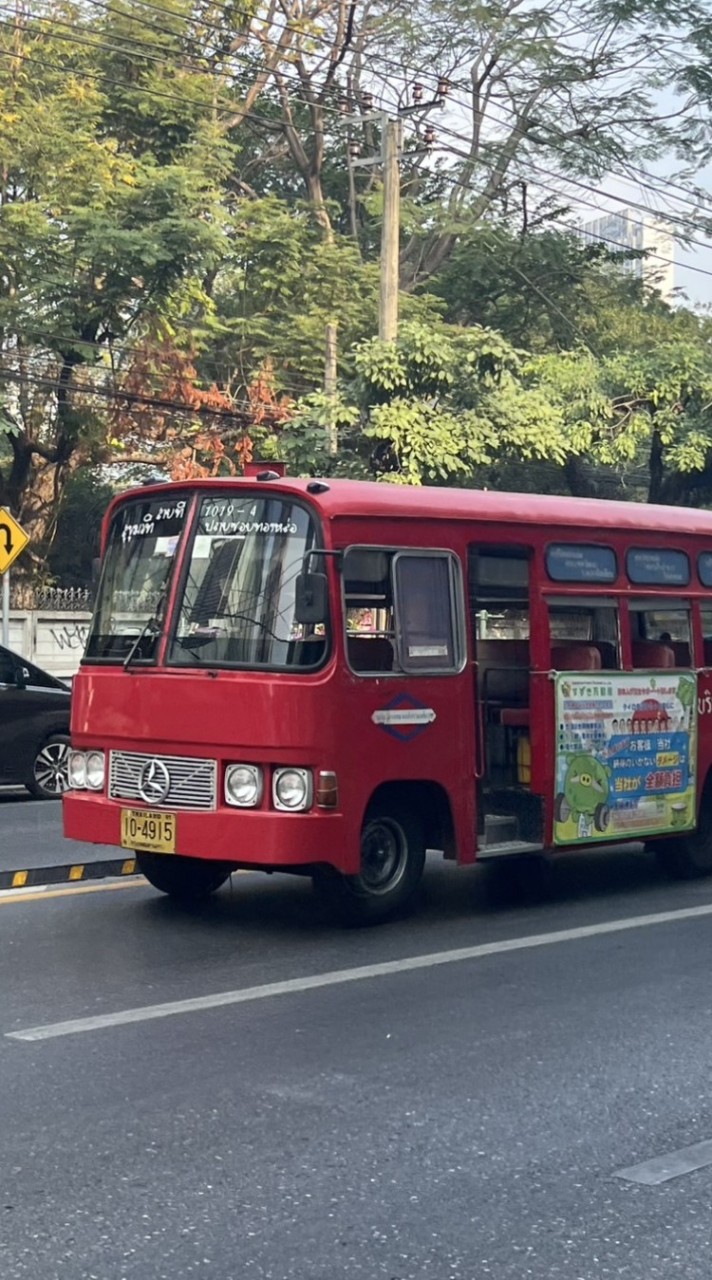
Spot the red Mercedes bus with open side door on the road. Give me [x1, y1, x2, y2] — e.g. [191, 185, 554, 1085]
[64, 470, 712, 923]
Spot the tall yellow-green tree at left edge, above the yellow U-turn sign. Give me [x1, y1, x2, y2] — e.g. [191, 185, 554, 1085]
[0, 3, 235, 541]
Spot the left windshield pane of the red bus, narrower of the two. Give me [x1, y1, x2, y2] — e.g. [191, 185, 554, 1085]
[86, 495, 188, 662]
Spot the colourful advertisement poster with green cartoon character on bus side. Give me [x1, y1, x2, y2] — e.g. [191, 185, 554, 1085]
[553, 671, 697, 845]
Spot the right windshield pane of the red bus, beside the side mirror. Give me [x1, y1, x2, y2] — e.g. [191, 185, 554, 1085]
[169, 494, 327, 668]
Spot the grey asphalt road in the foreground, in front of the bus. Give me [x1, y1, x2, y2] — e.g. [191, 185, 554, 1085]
[0, 810, 712, 1280]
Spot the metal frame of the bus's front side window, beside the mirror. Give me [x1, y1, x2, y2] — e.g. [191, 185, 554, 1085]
[339, 543, 469, 680]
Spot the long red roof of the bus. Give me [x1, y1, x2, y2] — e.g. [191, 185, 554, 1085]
[128, 481, 712, 536]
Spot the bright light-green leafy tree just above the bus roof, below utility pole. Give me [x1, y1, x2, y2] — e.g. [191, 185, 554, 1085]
[286, 324, 567, 484]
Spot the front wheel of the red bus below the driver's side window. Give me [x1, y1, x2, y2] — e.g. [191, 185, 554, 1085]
[315, 797, 425, 925]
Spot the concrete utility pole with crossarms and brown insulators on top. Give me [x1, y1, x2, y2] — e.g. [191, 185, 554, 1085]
[339, 77, 449, 342]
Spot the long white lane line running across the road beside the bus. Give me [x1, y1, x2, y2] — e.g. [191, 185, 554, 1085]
[11, 902, 712, 1041]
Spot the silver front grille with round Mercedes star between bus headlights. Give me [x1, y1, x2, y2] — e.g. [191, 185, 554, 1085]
[109, 751, 218, 810]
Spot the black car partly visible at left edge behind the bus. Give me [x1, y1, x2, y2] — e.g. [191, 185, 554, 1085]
[0, 645, 72, 800]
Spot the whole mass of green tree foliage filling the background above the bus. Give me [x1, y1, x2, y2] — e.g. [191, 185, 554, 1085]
[0, 0, 712, 581]
